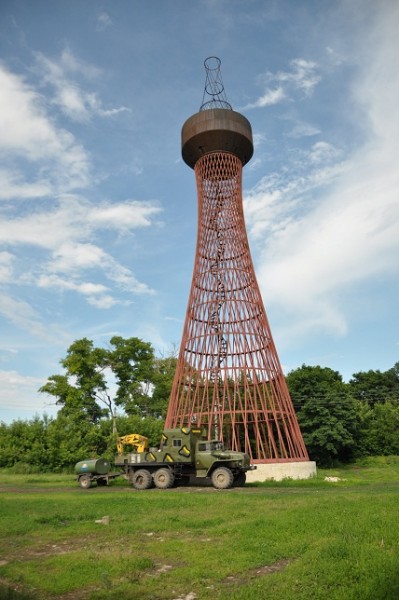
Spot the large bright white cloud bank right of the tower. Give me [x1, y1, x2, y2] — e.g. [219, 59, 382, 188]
[246, 2, 399, 337]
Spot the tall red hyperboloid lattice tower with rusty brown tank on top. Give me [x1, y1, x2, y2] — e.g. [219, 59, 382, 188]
[166, 57, 309, 463]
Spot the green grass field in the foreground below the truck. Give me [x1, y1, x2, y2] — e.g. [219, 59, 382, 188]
[0, 457, 399, 600]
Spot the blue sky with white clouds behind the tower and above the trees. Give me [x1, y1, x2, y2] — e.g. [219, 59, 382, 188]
[0, 0, 399, 422]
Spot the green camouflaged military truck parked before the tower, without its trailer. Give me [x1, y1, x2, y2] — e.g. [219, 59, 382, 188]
[115, 427, 256, 490]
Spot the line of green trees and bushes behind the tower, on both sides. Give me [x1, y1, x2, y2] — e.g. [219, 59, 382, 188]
[0, 336, 399, 472]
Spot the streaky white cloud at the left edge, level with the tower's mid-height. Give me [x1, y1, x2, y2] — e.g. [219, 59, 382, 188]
[0, 195, 160, 295]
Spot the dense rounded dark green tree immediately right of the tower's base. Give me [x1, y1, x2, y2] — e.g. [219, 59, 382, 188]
[287, 365, 356, 466]
